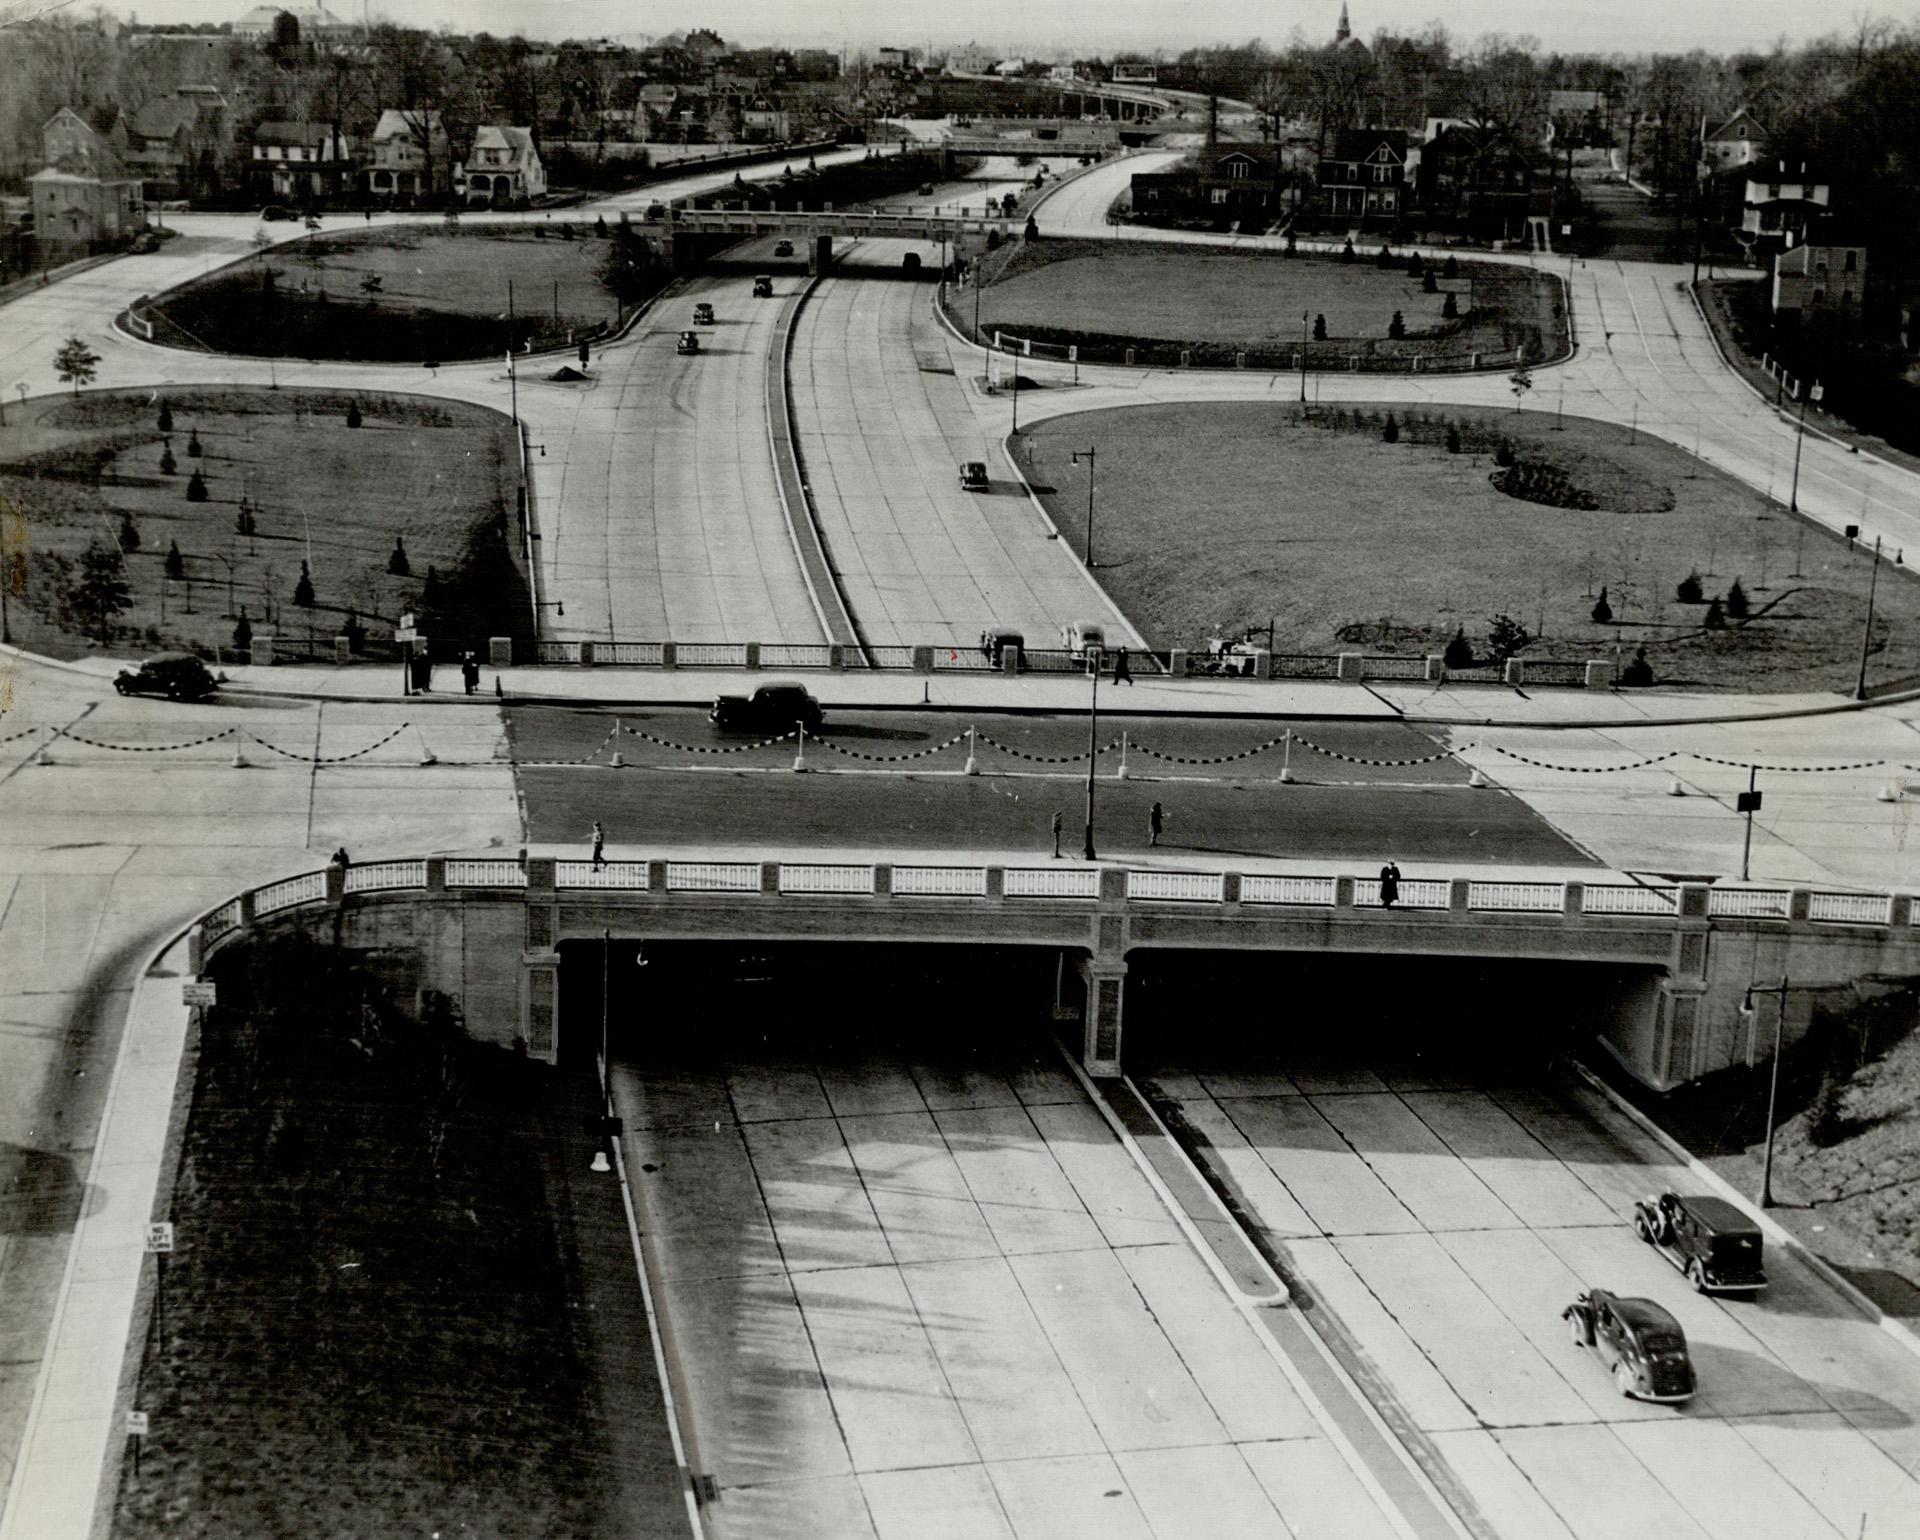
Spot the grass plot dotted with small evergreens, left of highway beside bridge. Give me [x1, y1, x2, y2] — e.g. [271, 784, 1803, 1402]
[0, 388, 530, 657]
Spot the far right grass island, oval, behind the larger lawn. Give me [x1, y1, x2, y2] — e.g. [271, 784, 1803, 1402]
[962, 240, 1565, 371]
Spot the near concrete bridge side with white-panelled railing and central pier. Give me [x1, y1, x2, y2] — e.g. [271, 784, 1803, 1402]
[190, 854, 1920, 1089]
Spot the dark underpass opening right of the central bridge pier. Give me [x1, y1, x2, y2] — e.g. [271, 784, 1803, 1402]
[1125, 949, 1663, 1081]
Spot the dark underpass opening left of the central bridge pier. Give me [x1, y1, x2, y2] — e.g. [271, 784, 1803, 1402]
[559, 937, 1085, 1068]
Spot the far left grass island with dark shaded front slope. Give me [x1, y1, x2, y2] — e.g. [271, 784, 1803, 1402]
[142, 217, 633, 363]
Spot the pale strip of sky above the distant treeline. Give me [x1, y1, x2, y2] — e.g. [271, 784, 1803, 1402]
[37, 0, 1920, 54]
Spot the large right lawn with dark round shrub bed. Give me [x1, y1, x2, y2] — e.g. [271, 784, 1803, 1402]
[1025, 403, 1920, 691]
